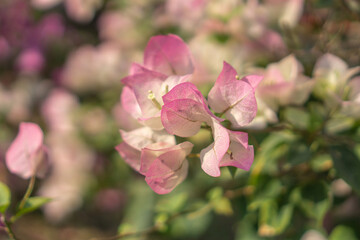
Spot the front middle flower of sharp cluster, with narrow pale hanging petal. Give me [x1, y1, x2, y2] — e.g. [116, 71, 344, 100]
[161, 79, 256, 177]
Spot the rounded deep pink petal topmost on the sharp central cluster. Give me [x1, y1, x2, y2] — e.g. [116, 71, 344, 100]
[144, 34, 194, 76]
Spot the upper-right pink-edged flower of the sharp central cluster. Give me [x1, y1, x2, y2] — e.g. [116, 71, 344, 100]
[208, 62, 262, 127]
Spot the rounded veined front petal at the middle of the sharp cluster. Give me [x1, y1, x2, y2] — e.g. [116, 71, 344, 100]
[161, 99, 210, 137]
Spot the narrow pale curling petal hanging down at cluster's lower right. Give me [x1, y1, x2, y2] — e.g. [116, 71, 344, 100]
[200, 120, 230, 177]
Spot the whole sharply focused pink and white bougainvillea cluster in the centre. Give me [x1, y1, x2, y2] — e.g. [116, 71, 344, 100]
[116, 35, 262, 194]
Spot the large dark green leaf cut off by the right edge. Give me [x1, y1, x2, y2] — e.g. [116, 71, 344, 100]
[330, 146, 360, 192]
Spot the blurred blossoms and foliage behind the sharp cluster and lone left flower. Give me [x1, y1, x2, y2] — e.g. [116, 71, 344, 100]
[0, 0, 360, 240]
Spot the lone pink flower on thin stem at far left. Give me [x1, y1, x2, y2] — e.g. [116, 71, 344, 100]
[6, 122, 48, 179]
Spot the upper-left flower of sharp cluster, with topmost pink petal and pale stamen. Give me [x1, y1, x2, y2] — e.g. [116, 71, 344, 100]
[121, 35, 194, 130]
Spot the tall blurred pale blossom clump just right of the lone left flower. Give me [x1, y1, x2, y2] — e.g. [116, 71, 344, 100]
[38, 132, 95, 223]
